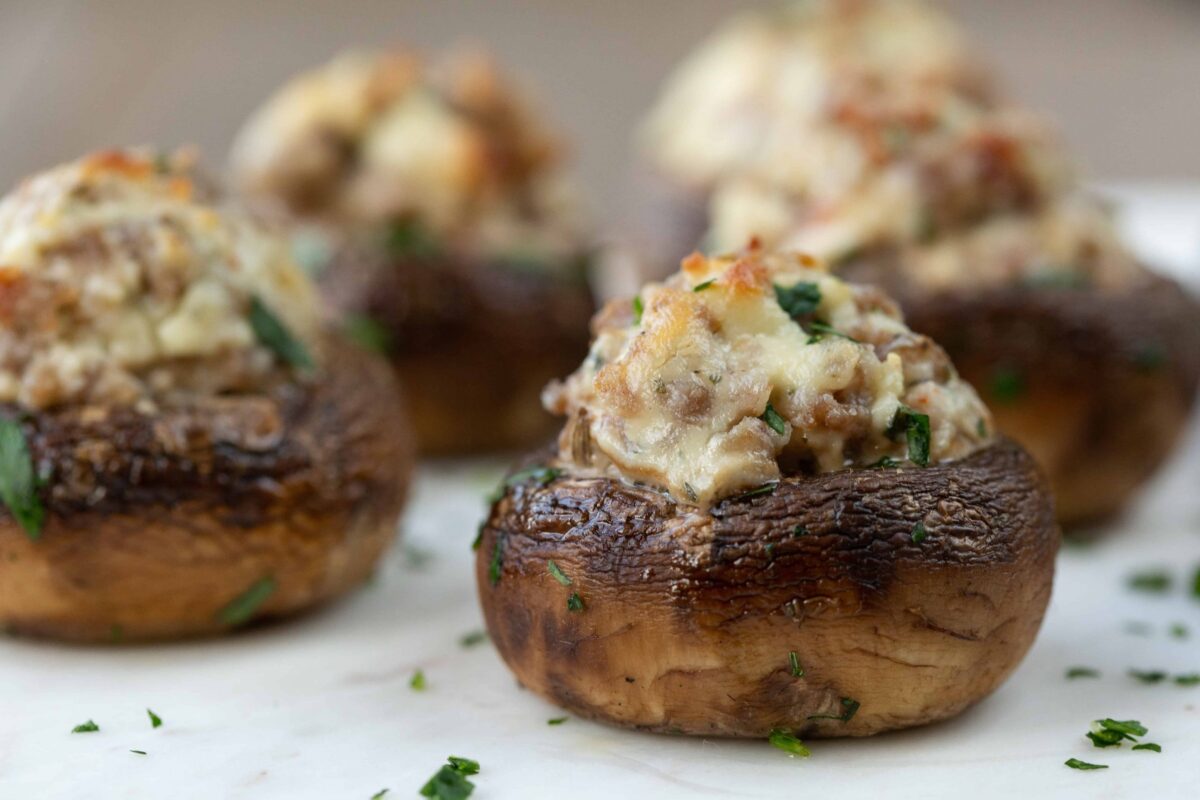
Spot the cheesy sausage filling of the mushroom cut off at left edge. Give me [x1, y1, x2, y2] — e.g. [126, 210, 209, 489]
[0, 152, 319, 409]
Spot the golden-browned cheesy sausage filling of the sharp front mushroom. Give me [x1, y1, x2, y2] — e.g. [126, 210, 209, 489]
[544, 249, 992, 504]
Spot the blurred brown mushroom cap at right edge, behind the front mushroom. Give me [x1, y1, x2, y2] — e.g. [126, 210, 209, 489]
[844, 262, 1200, 525]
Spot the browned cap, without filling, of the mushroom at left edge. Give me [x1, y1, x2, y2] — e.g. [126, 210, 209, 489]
[0, 344, 413, 640]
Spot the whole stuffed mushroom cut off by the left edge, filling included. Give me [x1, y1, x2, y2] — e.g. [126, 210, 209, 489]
[0, 151, 413, 640]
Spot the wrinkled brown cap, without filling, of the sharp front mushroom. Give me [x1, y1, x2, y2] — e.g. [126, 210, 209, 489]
[476, 440, 1058, 738]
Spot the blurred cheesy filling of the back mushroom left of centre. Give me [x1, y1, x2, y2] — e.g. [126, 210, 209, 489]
[233, 52, 580, 262]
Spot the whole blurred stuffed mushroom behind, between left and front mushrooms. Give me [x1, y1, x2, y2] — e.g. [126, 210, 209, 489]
[233, 52, 593, 455]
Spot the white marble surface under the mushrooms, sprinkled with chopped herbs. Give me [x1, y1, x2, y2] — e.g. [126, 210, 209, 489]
[0, 190, 1200, 800]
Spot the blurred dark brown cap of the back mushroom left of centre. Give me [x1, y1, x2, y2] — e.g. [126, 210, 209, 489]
[322, 248, 595, 456]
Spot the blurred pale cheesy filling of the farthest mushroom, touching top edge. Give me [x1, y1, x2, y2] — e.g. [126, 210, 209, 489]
[643, 0, 991, 194]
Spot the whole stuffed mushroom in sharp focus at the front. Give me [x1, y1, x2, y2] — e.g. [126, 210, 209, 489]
[476, 248, 1057, 738]
